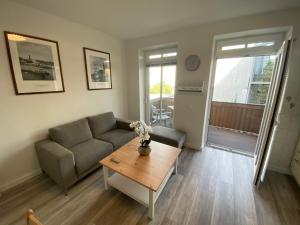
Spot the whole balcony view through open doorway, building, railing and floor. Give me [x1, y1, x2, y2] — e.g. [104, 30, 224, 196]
[207, 55, 276, 155]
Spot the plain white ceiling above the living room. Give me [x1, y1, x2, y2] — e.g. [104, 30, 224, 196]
[13, 0, 300, 39]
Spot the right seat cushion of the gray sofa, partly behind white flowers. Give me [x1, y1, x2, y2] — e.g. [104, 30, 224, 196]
[96, 129, 135, 150]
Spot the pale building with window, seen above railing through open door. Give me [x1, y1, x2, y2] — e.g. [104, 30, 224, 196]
[213, 56, 275, 105]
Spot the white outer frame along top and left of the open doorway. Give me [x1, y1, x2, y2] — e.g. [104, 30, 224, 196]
[201, 26, 293, 184]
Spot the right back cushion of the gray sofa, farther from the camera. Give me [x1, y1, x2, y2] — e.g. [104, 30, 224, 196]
[88, 112, 117, 137]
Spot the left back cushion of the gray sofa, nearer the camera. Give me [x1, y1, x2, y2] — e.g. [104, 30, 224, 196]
[49, 119, 92, 148]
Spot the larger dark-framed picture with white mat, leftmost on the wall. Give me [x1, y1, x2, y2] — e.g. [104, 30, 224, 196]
[4, 31, 65, 95]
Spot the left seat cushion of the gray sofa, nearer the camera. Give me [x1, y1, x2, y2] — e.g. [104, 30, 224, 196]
[70, 139, 113, 175]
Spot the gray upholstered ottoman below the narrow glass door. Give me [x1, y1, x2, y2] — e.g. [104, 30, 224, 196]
[150, 126, 186, 148]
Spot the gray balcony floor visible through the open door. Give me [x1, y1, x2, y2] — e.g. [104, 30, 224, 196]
[207, 126, 257, 155]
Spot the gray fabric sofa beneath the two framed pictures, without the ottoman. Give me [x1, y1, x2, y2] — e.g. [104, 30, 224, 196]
[35, 112, 135, 193]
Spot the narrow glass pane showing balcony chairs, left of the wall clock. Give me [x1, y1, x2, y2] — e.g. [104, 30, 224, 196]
[147, 65, 176, 127]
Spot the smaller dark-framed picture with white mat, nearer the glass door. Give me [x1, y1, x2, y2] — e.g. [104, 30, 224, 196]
[83, 48, 112, 90]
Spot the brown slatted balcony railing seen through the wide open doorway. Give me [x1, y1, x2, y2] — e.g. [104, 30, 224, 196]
[210, 101, 264, 134]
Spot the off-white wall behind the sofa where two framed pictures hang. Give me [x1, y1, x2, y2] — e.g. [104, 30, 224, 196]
[0, 1, 127, 190]
